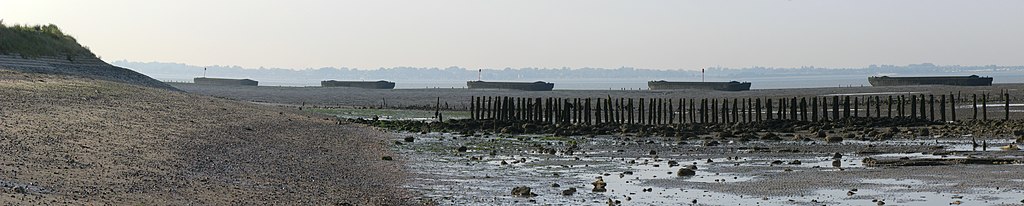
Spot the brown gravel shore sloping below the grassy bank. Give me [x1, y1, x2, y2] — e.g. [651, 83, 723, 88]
[0, 70, 415, 205]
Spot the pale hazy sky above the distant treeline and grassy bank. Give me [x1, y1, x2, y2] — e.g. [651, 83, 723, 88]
[0, 0, 1024, 70]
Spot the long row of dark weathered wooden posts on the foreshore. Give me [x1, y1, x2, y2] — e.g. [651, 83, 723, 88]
[470, 93, 1010, 125]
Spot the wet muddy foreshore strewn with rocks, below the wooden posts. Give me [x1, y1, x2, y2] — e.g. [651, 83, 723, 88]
[366, 118, 1024, 205]
